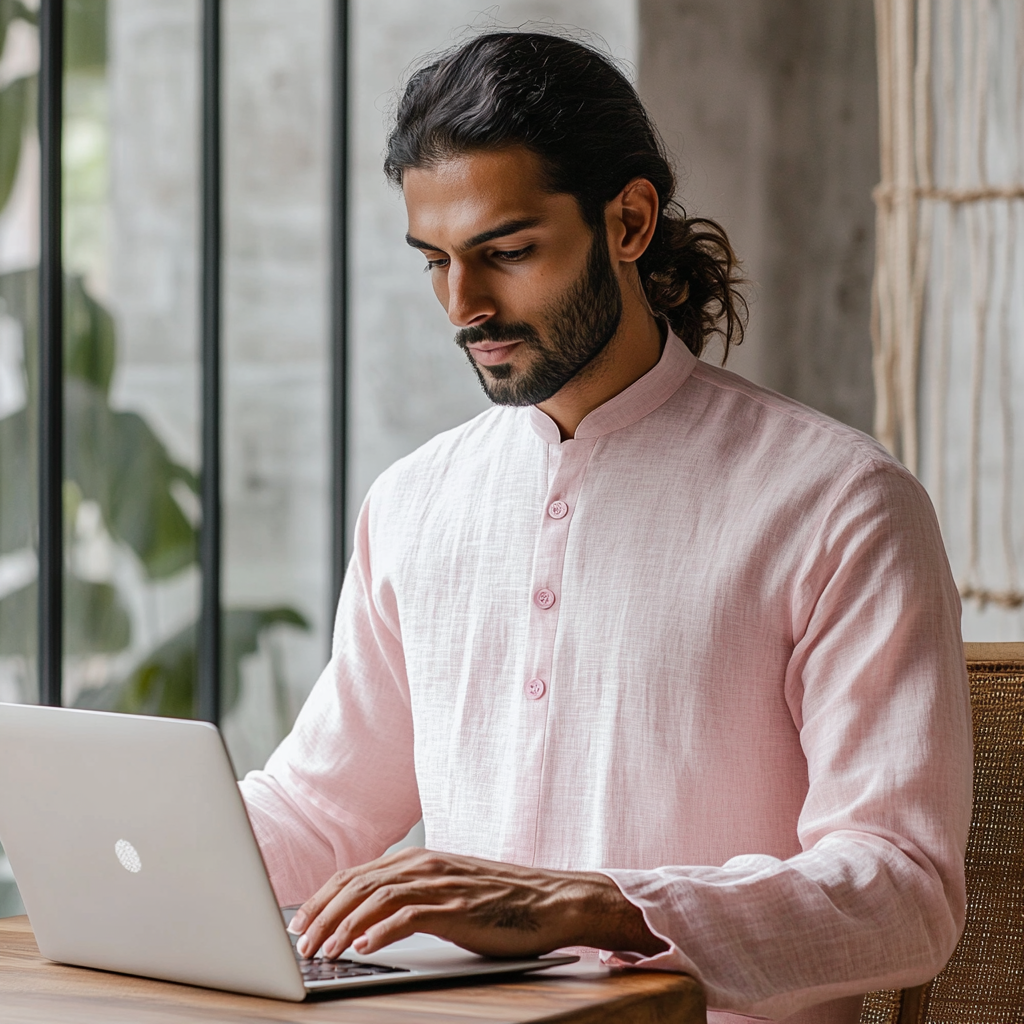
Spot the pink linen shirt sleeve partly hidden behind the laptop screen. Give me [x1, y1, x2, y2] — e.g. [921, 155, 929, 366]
[240, 492, 421, 906]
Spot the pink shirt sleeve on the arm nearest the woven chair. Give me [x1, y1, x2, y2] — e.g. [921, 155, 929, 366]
[605, 462, 973, 1019]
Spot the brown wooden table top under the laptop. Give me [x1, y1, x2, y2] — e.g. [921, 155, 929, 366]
[0, 918, 707, 1024]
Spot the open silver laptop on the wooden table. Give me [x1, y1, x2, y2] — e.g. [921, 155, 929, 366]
[0, 703, 579, 1001]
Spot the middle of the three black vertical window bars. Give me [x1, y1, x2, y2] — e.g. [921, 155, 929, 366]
[197, 0, 221, 722]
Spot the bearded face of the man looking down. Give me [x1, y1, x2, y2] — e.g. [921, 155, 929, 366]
[402, 147, 623, 406]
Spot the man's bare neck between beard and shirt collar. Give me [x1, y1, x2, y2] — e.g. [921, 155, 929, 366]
[537, 302, 665, 440]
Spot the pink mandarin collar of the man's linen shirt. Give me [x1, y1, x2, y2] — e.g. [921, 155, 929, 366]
[529, 331, 697, 444]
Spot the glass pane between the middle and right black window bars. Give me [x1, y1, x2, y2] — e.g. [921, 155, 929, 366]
[222, 0, 332, 773]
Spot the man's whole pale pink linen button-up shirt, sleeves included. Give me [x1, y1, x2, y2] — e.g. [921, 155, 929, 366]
[242, 335, 972, 1024]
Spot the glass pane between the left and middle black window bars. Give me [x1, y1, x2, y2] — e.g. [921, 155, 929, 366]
[63, 0, 199, 717]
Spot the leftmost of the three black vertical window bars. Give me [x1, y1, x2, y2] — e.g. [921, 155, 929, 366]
[37, 0, 65, 707]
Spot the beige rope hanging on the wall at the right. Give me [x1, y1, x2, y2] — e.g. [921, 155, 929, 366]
[872, 0, 1024, 609]
